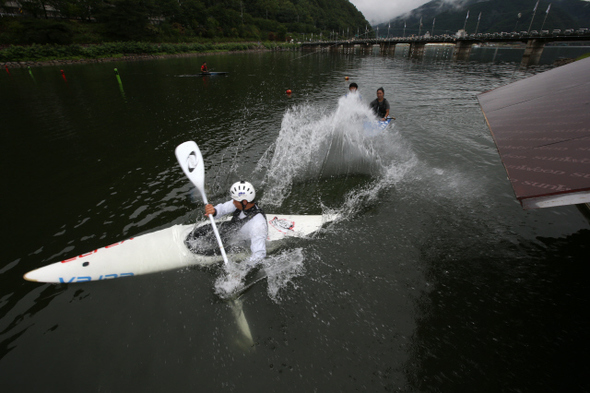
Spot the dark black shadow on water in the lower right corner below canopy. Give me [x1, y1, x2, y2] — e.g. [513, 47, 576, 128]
[406, 230, 590, 391]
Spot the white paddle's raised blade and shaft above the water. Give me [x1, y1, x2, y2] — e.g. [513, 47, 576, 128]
[174, 141, 229, 267]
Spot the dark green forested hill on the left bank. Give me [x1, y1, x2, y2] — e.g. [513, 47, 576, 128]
[0, 0, 368, 44]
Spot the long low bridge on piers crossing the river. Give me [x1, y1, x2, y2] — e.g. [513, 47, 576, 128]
[301, 29, 590, 67]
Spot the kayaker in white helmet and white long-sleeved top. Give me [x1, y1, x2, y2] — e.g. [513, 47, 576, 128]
[185, 180, 268, 267]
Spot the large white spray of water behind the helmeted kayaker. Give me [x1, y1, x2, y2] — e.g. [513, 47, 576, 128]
[257, 94, 417, 215]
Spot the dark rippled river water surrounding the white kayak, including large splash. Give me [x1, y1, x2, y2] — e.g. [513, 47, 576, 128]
[0, 48, 590, 392]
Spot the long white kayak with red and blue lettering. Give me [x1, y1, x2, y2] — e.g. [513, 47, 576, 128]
[24, 214, 336, 283]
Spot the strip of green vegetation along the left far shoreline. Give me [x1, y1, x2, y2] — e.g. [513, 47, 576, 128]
[0, 42, 299, 67]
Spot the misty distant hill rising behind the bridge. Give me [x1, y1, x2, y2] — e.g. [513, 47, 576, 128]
[373, 0, 590, 37]
